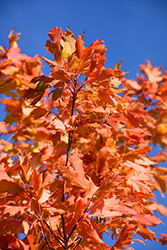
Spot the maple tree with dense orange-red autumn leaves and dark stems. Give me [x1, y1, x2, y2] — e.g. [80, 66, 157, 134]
[0, 27, 167, 250]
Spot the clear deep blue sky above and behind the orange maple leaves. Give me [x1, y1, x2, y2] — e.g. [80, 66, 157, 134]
[0, 0, 167, 250]
